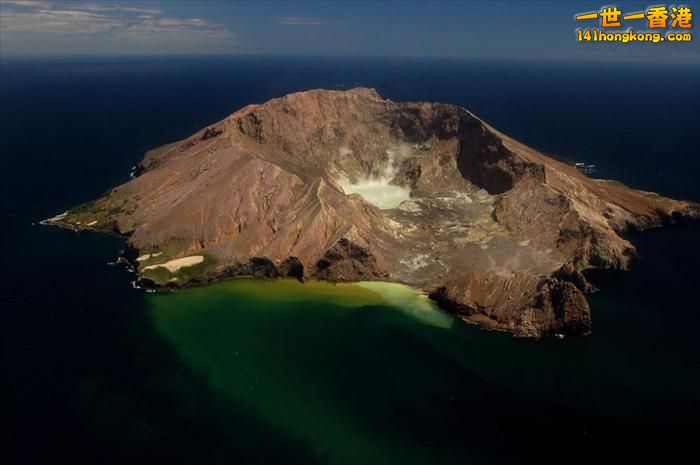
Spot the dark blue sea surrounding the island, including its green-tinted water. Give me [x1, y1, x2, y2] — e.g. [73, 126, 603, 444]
[0, 57, 700, 465]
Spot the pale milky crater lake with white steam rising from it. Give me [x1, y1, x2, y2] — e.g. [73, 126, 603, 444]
[340, 150, 411, 210]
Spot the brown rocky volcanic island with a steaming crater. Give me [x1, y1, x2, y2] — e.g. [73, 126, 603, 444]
[47, 88, 700, 336]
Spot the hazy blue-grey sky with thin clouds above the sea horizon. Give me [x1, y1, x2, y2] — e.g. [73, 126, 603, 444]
[0, 0, 700, 63]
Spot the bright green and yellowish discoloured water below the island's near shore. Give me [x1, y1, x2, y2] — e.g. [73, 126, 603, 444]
[151, 280, 462, 464]
